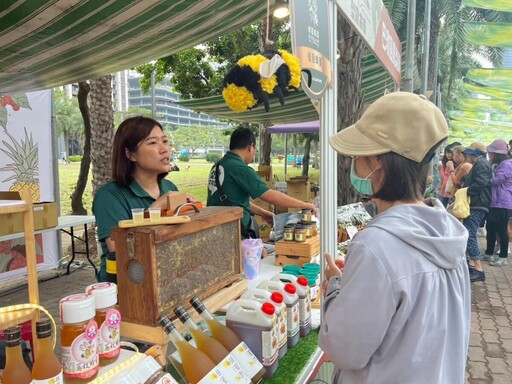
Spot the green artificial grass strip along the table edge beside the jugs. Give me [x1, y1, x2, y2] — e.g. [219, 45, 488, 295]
[260, 328, 318, 384]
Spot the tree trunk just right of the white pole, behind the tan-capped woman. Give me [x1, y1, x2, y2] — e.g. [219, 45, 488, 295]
[338, 12, 364, 206]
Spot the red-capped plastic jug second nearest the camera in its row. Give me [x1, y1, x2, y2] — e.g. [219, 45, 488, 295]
[240, 288, 288, 359]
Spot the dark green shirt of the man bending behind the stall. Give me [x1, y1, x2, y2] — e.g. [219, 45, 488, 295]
[207, 152, 270, 228]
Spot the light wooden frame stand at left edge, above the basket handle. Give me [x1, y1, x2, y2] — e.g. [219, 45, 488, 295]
[0, 191, 39, 352]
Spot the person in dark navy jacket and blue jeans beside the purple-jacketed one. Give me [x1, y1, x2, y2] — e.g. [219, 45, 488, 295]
[462, 142, 492, 283]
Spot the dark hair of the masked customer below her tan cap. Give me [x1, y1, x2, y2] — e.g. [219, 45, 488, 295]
[374, 152, 429, 202]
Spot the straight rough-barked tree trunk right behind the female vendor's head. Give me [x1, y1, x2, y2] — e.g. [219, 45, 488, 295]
[90, 75, 114, 196]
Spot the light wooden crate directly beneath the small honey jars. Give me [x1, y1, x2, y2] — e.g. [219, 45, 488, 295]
[275, 236, 320, 266]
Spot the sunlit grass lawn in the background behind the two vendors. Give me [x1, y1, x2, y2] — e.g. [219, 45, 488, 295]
[59, 159, 319, 215]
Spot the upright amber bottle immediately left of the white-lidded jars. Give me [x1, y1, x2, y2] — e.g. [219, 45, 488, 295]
[32, 318, 63, 384]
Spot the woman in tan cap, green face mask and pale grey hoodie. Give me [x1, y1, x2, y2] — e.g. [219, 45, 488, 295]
[318, 92, 471, 384]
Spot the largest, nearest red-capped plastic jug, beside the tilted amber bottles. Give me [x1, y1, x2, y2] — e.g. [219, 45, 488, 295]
[226, 299, 279, 379]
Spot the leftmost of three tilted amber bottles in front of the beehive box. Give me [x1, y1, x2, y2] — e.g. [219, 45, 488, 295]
[158, 314, 215, 384]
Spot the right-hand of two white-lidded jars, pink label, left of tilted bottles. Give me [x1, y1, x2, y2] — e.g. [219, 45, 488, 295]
[85, 283, 121, 366]
